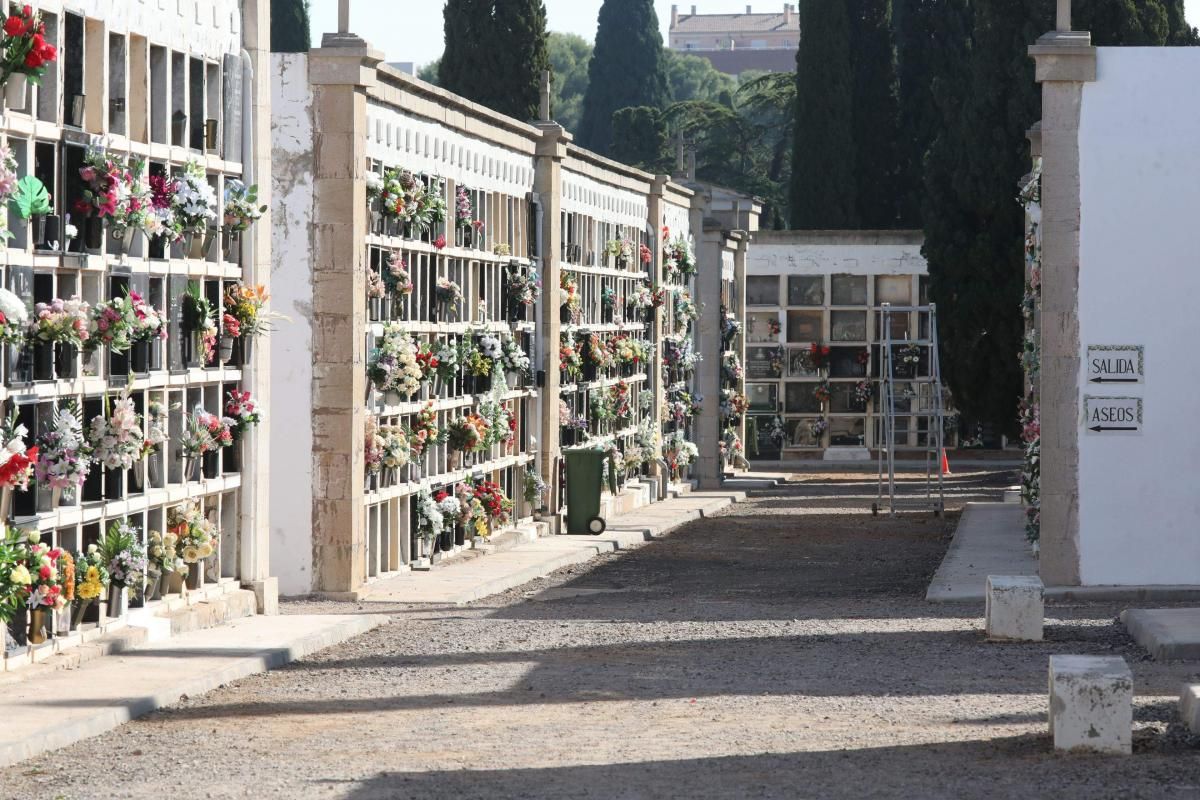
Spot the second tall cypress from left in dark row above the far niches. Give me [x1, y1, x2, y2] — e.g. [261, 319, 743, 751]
[849, 0, 900, 228]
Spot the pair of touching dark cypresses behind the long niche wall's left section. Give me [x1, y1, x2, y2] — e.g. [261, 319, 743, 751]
[438, 0, 550, 120]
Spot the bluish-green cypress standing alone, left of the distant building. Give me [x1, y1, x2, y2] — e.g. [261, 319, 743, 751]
[578, 0, 670, 155]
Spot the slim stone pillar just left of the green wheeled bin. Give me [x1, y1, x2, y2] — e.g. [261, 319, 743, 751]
[530, 122, 570, 534]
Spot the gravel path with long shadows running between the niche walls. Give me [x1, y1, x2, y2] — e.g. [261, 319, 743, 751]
[0, 473, 1200, 800]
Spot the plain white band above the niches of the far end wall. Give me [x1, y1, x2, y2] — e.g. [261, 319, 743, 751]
[746, 231, 929, 275]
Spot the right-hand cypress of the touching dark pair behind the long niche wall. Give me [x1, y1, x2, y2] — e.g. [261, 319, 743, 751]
[489, 0, 550, 120]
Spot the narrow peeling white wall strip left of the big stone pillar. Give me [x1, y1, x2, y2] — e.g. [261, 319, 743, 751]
[269, 53, 313, 595]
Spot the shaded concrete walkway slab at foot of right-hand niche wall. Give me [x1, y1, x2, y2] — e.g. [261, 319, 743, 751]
[925, 503, 1038, 602]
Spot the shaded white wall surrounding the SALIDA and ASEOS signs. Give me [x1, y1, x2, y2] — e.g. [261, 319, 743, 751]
[1079, 48, 1200, 585]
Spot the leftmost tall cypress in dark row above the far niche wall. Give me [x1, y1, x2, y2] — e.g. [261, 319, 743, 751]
[791, 0, 859, 229]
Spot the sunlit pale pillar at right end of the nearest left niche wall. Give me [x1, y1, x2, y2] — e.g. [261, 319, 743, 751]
[238, 0, 280, 614]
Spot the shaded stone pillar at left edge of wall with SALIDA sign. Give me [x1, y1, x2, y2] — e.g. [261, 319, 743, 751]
[1030, 31, 1096, 587]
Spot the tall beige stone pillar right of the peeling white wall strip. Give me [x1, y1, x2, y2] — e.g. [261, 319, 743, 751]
[308, 35, 383, 595]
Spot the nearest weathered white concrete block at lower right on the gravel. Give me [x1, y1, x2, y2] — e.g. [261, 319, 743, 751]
[1050, 656, 1133, 756]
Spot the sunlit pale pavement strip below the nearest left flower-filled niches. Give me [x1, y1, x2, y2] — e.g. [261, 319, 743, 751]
[0, 615, 386, 766]
